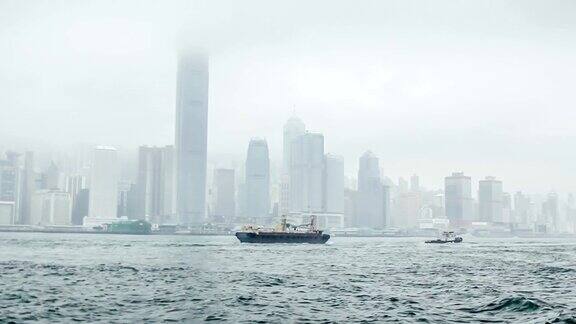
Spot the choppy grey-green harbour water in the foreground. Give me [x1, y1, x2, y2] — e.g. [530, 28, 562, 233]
[0, 233, 576, 323]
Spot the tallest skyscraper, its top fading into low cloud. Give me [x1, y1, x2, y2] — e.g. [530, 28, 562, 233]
[176, 51, 208, 224]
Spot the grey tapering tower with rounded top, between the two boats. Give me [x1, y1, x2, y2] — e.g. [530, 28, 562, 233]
[356, 151, 389, 228]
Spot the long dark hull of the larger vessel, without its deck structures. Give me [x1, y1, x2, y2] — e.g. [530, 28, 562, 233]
[236, 232, 330, 244]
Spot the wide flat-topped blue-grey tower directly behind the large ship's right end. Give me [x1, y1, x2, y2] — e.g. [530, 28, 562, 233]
[290, 133, 324, 213]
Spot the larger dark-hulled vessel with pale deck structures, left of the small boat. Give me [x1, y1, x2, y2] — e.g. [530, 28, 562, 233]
[236, 215, 330, 244]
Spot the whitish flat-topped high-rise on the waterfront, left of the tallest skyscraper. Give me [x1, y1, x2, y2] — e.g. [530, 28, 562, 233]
[88, 146, 118, 223]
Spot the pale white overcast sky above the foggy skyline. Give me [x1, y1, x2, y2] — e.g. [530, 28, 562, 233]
[0, 0, 576, 192]
